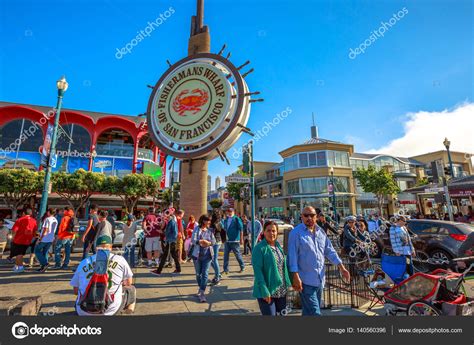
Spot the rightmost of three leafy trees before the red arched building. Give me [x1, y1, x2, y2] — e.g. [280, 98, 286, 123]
[103, 174, 160, 213]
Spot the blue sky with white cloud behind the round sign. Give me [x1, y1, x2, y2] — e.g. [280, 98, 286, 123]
[0, 0, 474, 185]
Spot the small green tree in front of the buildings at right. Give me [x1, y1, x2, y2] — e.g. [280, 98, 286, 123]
[354, 165, 400, 215]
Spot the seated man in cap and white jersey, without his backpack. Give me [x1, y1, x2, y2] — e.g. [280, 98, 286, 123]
[70, 235, 136, 316]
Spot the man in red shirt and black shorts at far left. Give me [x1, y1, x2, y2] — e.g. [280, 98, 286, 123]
[10, 208, 38, 273]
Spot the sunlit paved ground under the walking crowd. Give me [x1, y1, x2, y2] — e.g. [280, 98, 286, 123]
[0, 253, 386, 315]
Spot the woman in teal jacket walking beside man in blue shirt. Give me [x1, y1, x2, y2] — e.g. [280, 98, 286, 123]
[252, 221, 291, 316]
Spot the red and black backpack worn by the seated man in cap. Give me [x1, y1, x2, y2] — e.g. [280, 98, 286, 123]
[79, 249, 114, 314]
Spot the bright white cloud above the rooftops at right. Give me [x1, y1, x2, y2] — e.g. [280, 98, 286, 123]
[368, 103, 474, 157]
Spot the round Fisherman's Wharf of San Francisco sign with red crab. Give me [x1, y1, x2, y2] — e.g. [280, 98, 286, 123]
[147, 48, 262, 160]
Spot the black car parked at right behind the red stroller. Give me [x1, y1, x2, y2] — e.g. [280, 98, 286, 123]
[381, 219, 474, 260]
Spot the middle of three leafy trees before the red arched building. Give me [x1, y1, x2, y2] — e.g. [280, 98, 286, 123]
[51, 169, 105, 213]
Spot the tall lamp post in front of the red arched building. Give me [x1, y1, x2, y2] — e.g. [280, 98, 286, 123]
[38, 76, 68, 228]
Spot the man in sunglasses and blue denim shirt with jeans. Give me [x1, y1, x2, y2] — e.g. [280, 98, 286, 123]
[288, 206, 350, 315]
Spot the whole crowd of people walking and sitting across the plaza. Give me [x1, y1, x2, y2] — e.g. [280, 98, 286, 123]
[0, 205, 472, 315]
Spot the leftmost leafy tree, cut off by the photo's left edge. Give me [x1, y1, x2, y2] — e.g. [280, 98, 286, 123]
[0, 168, 44, 219]
